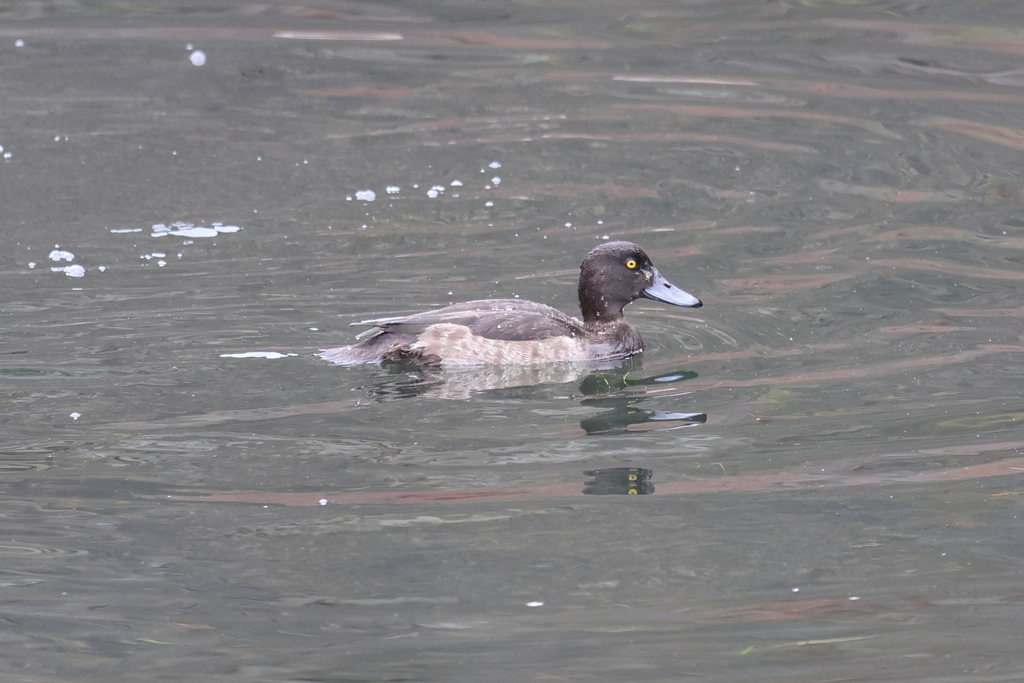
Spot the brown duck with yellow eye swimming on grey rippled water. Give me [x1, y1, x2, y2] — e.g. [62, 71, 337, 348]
[318, 242, 703, 368]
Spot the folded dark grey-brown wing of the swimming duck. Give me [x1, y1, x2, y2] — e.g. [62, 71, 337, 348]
[353, 299, 583, 341]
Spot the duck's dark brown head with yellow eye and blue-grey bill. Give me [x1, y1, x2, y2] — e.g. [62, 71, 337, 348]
[580, 242, 702, 325]
